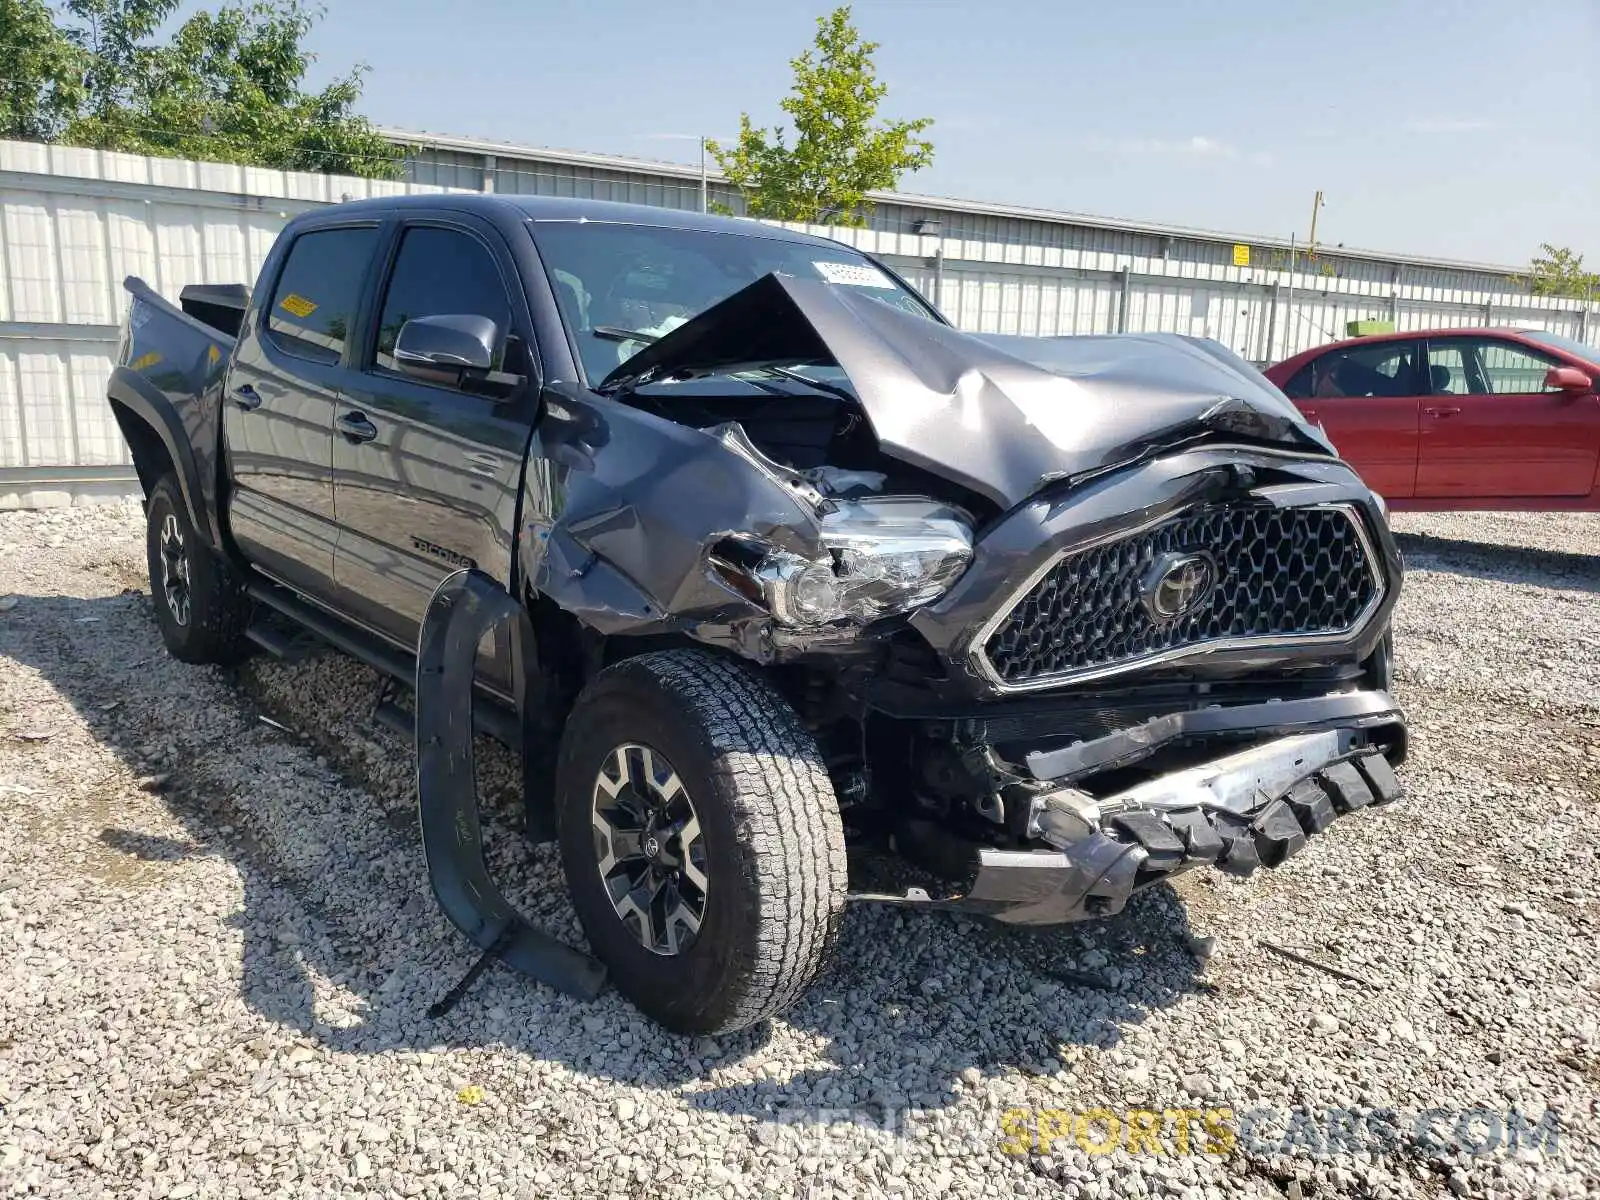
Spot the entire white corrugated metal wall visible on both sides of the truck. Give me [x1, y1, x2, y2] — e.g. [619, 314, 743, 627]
[0, 142, 1600, 504]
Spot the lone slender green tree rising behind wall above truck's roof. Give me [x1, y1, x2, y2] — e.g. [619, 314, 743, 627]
[707, 6, 933, 224]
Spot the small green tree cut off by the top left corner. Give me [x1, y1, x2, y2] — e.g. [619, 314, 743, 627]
[0, 0, 85, 142]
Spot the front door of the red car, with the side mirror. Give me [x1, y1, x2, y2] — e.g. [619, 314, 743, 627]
[1416, 336, 1600, 499]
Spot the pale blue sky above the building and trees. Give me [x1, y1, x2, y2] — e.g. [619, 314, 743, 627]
[294, 0, 1600, 266]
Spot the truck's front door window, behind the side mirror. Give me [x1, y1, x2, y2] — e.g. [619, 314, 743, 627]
[373, 226, 510, 371]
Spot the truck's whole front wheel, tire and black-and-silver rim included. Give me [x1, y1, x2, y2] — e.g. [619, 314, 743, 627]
[557, 650, 846, 1034]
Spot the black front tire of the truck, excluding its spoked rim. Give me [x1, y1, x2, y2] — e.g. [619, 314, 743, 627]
[557, 650, 846, 1034]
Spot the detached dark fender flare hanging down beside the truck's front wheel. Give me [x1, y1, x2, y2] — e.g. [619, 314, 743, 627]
[416, 570, 605, 1016]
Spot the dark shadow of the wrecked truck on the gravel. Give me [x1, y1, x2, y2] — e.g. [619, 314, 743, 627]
[0, 592, 1208, 1123]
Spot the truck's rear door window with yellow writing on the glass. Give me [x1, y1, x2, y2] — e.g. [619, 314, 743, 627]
[266, 227, 378, 363]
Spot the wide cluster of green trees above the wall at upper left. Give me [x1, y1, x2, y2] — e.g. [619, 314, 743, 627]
[0, 0, 403, 179]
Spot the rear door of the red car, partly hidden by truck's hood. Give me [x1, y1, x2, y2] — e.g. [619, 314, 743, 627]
[1283, 339, 1422, 499]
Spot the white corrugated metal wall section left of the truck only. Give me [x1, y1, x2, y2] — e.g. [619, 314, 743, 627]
[0, 141, 464, 504]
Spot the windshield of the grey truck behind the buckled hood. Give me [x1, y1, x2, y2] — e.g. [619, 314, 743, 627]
[530, 221, 933, 382]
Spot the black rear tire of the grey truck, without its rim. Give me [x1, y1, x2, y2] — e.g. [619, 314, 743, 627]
[144, 475, 251, 662]
